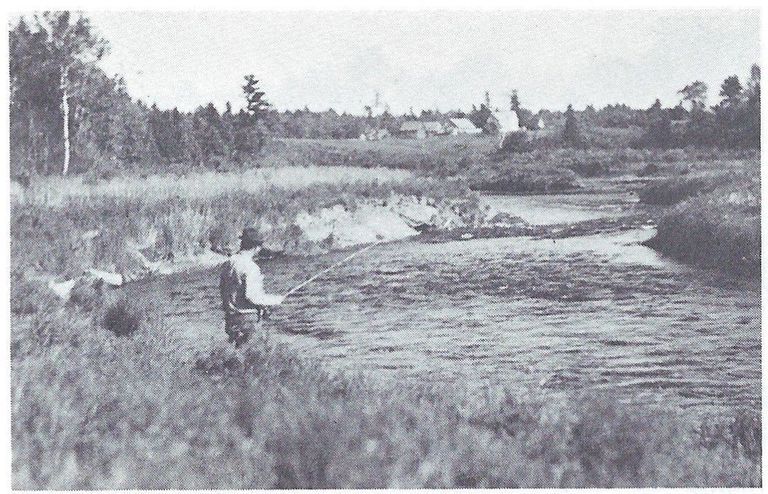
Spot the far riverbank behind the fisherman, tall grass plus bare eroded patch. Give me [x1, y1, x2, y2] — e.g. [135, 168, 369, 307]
[11, 167, 483, 307]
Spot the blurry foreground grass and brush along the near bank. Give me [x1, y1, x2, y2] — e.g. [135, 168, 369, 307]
[11, 305, 761, 489]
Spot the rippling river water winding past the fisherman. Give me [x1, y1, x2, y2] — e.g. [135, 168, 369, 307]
[129, 193, 760, 412]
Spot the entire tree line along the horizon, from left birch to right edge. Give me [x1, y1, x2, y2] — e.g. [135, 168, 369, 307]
[9, 12, 760, 176]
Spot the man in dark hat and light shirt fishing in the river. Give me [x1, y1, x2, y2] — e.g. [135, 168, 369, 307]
[219, 227, 285, 347]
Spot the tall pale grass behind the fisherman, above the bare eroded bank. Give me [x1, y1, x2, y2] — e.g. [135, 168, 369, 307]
[11, 167, 476, 279]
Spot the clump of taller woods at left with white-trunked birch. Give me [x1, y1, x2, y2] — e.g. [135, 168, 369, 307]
[10, 12, 269, 175]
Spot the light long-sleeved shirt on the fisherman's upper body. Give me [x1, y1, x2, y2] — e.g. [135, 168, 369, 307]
[219, 251, 284, 310]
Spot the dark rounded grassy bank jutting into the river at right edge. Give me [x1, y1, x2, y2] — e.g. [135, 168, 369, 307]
[640, 159, 761, 276]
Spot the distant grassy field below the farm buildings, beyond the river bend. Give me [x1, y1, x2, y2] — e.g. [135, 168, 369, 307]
[272, 138, 754, 193]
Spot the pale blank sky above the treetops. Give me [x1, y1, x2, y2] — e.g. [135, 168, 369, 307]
[82, 10, 760, 114]
